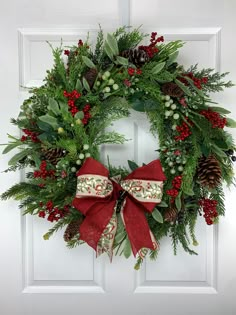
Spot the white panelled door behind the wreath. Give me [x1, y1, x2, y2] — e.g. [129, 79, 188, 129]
[0, 0, 236, 315]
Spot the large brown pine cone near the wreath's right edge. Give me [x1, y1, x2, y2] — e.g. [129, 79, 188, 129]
[197, 155, 222, 189]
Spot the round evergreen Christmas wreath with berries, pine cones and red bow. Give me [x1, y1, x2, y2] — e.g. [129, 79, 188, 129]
[1, 27, 236, 268]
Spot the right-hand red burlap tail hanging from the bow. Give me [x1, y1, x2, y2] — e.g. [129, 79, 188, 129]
[121, 197, 159, 258]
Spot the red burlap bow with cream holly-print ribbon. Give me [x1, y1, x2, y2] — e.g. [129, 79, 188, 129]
[73, 158, 166, 257]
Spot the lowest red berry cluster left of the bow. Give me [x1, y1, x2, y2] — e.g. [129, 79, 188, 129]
[38, 200, 69, 222]
